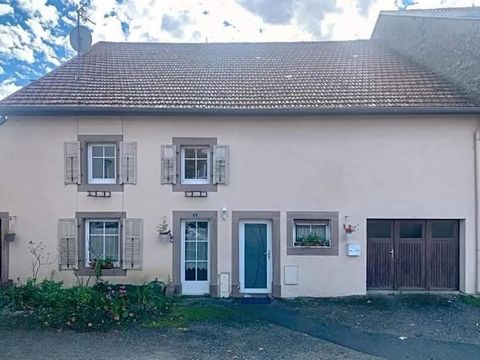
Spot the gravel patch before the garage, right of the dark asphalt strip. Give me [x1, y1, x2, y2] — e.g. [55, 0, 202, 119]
[272, 294, 480, 345]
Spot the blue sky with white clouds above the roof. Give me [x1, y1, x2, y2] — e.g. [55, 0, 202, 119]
[0, 0, 480, 99]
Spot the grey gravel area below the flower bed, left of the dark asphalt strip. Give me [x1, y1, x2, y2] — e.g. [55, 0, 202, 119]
[0, 321, 375, 360]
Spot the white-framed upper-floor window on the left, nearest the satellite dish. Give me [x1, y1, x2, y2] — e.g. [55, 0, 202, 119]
[88, 144, 117, 184]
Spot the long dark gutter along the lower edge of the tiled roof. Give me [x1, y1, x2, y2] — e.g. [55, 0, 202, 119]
[0, 105, 480, 116]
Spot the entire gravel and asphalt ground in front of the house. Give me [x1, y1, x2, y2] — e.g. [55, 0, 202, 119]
[0, 295, 480, 360]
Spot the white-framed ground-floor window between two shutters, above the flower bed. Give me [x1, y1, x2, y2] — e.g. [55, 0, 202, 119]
[85, 219, 120, 267]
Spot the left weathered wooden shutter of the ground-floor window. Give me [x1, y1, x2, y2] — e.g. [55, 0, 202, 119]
[58, 219, 78, 270]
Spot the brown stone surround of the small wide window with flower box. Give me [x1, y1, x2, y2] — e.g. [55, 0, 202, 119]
[287, 211, 339, 256]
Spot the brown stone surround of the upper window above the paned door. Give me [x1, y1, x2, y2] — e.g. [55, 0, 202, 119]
[172, 137, 217, 192]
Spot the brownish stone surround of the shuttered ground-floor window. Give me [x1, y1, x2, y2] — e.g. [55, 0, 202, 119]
[75, 211, 127, 276]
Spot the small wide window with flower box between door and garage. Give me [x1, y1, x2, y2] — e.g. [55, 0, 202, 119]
[293, 220, 332, 248]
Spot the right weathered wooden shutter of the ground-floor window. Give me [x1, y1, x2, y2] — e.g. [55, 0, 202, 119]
[123, 219, 143, 270]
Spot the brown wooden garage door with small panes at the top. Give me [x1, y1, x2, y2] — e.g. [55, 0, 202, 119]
[367, 219, 459, 290]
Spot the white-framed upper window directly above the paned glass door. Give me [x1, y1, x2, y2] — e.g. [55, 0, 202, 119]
[181, 146, 210, 184]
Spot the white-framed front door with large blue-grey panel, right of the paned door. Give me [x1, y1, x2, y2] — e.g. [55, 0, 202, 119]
[239, 220, 272, 294]
